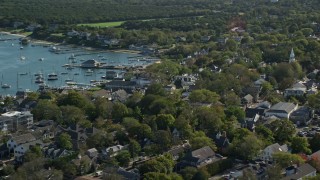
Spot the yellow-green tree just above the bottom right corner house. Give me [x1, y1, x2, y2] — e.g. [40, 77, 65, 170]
[272, 152, 304, 168]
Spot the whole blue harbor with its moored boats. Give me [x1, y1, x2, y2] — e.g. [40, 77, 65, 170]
[0, 34, 153, 95]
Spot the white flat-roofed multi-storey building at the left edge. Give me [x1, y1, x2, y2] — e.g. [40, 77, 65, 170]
[0, 111, 33, 132]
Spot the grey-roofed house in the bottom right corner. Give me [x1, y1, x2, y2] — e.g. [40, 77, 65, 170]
[282, 163, 317, 180]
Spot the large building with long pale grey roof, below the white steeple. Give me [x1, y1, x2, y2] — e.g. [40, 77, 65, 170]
[265, 102, 298, 119]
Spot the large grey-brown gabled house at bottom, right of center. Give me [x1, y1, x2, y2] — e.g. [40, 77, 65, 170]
[182, 146, 219, 168]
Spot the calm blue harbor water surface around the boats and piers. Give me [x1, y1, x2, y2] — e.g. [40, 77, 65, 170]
[0, 34, 141, 95]
